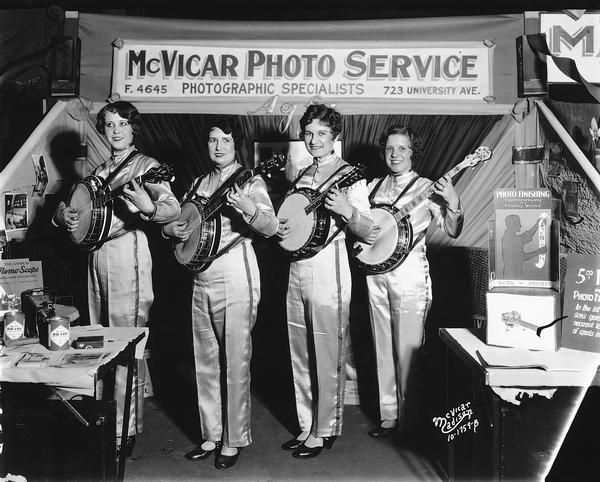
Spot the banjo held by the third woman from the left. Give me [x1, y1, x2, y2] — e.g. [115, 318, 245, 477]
[277, 164, 366, 259]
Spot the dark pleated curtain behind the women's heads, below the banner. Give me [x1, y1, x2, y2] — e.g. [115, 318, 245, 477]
[136, 114, 501, 196]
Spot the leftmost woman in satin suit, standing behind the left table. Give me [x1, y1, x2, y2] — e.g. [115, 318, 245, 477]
[54, 101, 180, 455]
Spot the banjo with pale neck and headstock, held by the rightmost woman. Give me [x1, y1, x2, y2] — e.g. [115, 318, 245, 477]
[350, 146, 492, 274]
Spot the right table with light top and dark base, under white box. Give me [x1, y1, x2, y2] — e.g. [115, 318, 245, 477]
[440, 328, 600, 480]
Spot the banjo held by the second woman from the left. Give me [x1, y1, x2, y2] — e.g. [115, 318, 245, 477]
[173, 154, 286, 272]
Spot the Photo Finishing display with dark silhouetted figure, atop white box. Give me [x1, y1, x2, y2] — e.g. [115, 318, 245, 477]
[488, 188, 560, 290]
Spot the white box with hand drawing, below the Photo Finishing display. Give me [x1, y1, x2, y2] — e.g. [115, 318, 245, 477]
[486, 288, 561, 351]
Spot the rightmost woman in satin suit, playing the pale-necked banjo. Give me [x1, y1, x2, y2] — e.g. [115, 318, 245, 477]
[360, 125, 464, 443]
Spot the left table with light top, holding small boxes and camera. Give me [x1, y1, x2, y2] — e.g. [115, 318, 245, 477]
[0, 327, 147, 481]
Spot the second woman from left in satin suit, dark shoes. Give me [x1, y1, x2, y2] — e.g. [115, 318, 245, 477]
[163, 116, 277, 469]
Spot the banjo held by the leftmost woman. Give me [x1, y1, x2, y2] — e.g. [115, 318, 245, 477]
[68, 164, 174, 251]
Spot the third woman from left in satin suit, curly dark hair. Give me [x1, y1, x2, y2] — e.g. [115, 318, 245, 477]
[277, 104, 373, 459]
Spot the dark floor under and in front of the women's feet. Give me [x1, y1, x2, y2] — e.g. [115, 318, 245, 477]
[125, 397, 442, 481]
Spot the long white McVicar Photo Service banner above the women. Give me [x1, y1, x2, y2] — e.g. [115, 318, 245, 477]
[112, 39, 493, 102]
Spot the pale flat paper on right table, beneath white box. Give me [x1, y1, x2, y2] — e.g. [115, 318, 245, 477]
[476, 348, 600, 372]
